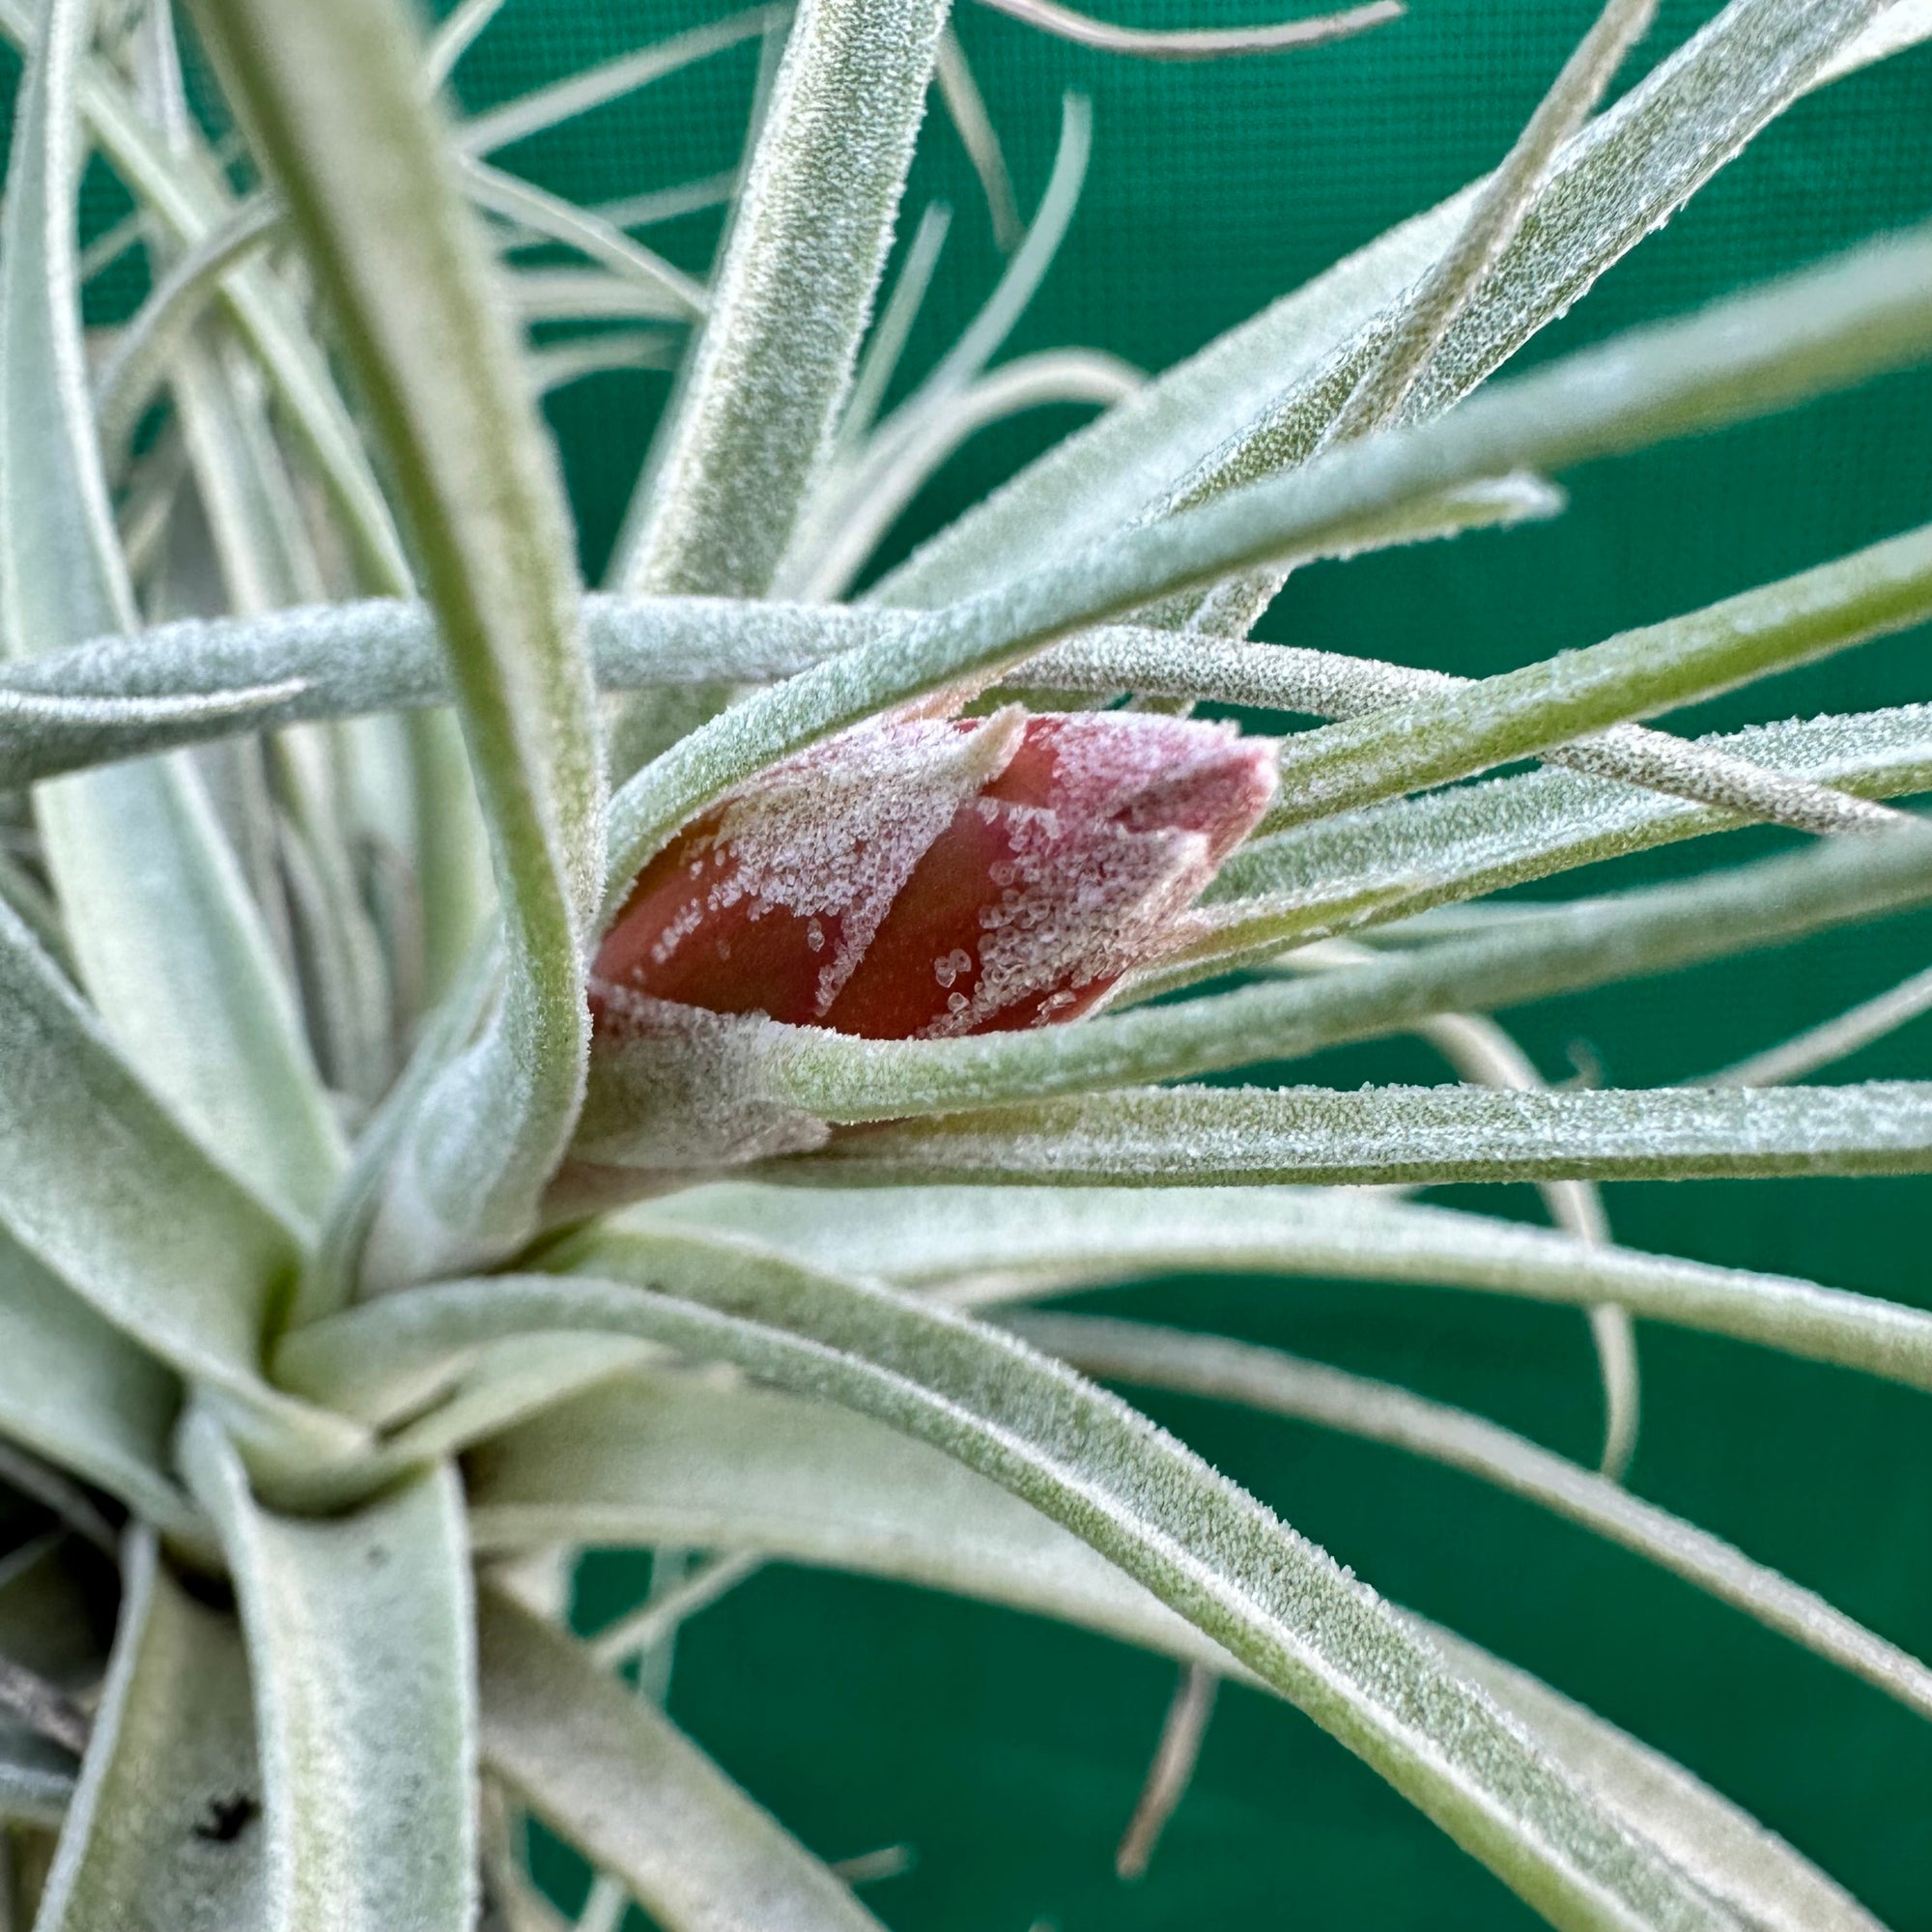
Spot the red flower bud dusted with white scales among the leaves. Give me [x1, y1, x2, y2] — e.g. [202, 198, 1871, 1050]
[593, 707, 1275, 1039]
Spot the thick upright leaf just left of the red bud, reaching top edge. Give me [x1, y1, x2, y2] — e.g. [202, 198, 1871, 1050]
[190, 0, 603, 1279]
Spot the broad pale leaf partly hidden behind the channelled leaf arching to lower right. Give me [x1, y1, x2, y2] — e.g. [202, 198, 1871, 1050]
[473, 1376, 1878, 1932]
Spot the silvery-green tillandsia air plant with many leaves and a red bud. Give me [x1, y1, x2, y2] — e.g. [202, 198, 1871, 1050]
[0, 0, 1932, 1932]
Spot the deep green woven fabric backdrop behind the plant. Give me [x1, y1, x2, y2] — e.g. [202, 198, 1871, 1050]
[439, 11, 1932, 1932]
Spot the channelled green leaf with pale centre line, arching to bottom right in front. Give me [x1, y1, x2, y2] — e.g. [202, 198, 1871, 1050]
[282, 1236, 1747, 1932]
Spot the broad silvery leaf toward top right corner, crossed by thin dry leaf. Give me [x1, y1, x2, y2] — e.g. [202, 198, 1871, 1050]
[885, 0, 1876, 607]
